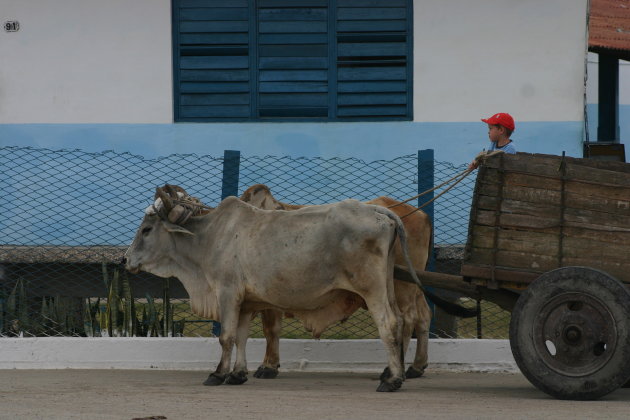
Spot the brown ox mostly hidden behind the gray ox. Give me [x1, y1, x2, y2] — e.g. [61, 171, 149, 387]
[241, 184, 476, 378]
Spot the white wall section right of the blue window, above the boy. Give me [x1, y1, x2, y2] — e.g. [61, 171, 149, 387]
[414, 0, 587, 126]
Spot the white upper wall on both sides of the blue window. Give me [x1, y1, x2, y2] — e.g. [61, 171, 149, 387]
[0, 0, 587, 124]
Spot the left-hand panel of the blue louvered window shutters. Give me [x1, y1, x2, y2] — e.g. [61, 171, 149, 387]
[173, 0, 252, 121]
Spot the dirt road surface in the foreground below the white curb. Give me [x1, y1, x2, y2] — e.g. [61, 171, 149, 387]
[0, 370, 630, 420]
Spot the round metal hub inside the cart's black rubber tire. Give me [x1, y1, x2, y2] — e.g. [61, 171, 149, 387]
[532, 292, 617, 376]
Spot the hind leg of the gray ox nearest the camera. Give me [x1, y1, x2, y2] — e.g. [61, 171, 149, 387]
[365, 299, 403, 392]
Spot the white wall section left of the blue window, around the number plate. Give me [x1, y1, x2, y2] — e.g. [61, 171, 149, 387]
[0, 0, 173, 123]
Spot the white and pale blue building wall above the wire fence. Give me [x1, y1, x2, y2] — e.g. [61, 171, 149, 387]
[0, 0, 587, 164]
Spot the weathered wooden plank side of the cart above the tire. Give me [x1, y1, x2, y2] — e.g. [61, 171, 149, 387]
[462, 153, 630, 289]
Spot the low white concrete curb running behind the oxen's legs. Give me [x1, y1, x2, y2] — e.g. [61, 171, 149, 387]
[0, 337, 518, 372]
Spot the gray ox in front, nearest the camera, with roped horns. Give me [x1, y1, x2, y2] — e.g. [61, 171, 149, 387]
[124, 185, 430, 391]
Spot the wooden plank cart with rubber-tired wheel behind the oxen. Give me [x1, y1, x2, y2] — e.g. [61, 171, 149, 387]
[397, 153, 630, 400]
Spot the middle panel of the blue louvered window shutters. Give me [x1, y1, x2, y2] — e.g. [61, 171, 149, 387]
[256, 0, 329, 120]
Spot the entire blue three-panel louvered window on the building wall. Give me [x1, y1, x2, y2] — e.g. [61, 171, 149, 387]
[172, 0, 413, 121]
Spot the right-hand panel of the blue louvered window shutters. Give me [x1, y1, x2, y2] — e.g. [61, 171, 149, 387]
[336, 0, 412, 120]
